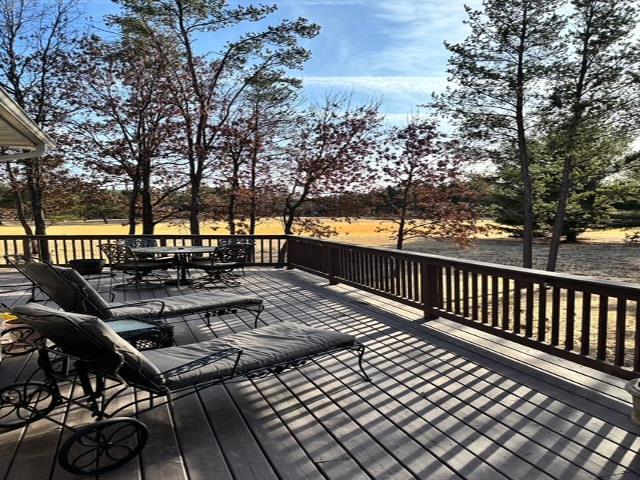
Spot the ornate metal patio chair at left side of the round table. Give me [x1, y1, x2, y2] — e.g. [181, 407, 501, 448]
[100, 242, 173, 288]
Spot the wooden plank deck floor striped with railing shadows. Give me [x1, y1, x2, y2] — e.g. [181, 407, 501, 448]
[0, 269, 640, 480]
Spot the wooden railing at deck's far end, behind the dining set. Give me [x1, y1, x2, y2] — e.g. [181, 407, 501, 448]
[0, 235, 286, 267]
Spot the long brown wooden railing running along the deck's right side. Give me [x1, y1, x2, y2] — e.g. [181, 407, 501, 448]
[288, 236, 640, 378]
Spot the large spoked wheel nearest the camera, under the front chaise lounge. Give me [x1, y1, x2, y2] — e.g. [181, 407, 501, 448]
[58, 417, 149, 475]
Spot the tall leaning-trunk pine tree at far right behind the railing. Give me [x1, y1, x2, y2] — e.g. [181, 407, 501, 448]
[547, 0, 640, 271]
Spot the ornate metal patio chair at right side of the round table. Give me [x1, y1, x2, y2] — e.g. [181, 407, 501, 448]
[187, 244, 250, 288]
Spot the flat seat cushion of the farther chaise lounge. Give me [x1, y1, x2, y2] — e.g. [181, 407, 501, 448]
[107, 293, 262, 319]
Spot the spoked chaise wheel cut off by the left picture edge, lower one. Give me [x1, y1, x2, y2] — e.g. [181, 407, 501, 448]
[0, 382, 60, 428]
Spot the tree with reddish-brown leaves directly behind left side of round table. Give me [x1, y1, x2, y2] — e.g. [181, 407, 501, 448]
[74, 31, 188, 234]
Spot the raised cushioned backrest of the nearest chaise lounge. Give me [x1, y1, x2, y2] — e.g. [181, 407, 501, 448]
[12, 304, 162, 389]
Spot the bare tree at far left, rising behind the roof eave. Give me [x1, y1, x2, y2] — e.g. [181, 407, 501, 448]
[0, 0, 79, 234]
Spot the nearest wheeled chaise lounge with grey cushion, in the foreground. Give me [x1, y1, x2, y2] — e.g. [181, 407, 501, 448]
[0, 305, 369, 475]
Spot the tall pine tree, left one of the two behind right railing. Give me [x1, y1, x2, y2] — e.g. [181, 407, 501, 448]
[434, 0, 563, 267]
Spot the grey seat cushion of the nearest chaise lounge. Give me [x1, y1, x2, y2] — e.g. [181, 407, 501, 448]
[143, 322, 355, 389]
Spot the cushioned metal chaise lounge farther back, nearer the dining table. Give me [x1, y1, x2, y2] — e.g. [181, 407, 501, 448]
[5, 256, 264, 327]
